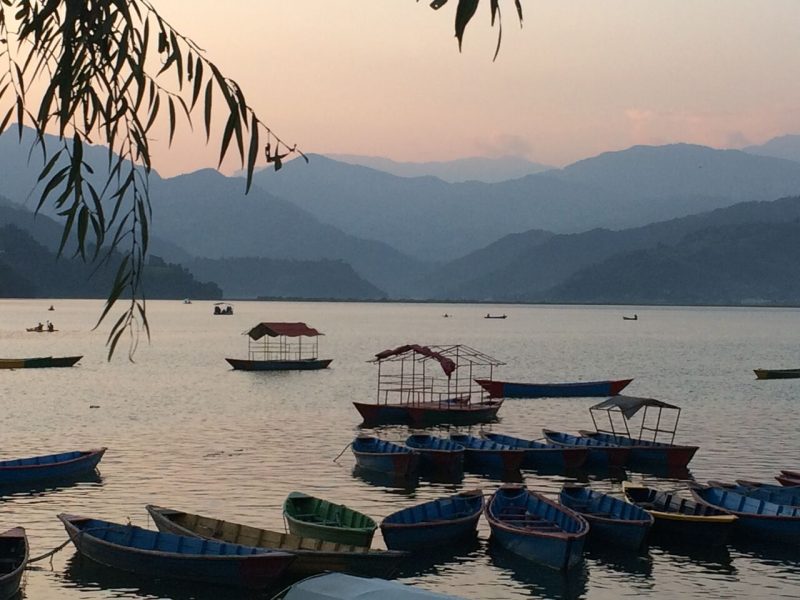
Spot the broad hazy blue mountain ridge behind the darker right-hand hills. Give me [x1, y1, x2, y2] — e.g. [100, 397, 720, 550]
[256, 144, 800, 262]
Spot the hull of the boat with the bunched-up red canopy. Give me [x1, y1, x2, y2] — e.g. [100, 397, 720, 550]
[353, 400, 503, 427]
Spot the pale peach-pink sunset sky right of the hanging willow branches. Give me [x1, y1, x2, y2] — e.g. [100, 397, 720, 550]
[148, 0, 800, 175]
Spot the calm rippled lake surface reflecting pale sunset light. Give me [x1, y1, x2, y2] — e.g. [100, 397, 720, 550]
[0, 300, 800, 600]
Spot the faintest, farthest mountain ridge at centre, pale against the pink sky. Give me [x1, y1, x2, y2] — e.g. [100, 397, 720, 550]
[326, 154, 553, 183]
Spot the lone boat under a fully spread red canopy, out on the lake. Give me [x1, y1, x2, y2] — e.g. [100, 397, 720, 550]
[225, 322, 333, 371]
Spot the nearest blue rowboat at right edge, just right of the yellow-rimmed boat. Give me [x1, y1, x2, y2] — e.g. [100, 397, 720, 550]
[691, 485, 800, 545]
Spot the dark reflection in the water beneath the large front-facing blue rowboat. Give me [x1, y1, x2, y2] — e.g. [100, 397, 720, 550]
[489, 540, 589, 600]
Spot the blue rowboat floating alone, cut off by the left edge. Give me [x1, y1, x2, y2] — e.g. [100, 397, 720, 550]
[0, 448, 106, 486]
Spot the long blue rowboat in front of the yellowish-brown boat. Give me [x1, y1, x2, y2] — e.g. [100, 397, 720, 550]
[58, 514, 295, 589]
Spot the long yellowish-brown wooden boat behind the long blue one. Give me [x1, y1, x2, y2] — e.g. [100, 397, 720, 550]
[147, 504, 408, 579]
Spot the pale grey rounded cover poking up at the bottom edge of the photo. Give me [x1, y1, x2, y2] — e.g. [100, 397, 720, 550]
[272, 573, 465, 600]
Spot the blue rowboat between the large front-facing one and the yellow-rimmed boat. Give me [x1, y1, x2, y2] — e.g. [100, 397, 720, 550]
[559, 485, 653, 550]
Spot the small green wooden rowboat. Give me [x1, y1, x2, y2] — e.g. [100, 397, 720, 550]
[283, 492, 378, 548]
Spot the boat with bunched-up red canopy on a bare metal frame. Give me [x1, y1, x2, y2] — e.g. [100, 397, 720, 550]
[353, 344, 505, 427]
